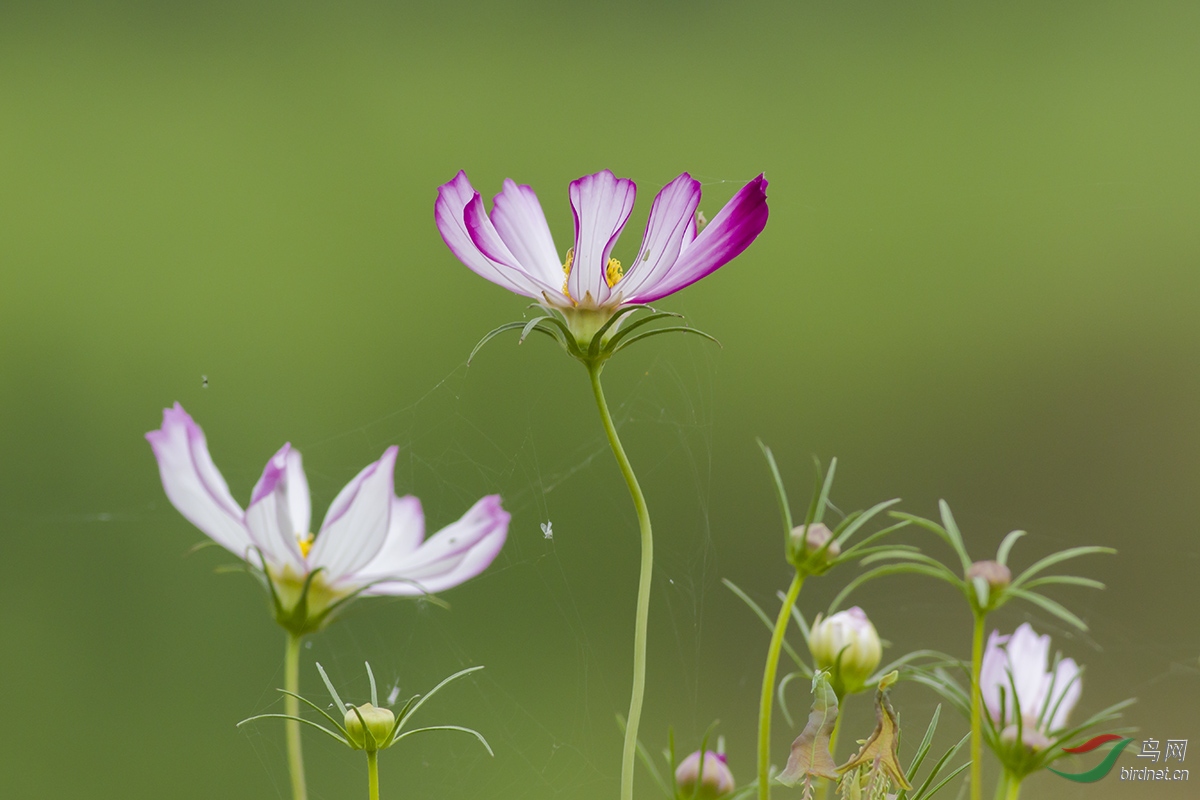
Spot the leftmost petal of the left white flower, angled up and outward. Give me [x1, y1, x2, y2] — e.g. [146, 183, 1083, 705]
[146, 403, 253, 558]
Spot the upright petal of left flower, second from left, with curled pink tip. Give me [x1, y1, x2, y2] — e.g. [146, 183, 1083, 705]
[246, 444, 312, 575]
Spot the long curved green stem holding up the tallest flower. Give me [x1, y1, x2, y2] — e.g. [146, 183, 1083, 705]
[588, 363, 654, 800]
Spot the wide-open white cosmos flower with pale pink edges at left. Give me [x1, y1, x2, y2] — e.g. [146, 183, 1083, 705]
[146, 403, 509, 625]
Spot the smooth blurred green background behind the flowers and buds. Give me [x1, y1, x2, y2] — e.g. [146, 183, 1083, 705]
[0, 0, 1200, 800]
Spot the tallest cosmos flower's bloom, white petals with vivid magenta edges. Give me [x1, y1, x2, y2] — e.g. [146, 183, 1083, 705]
[434, 169, 768, 317]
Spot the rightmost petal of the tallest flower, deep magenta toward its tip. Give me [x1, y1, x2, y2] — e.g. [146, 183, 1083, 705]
[624, 175, 769, 302]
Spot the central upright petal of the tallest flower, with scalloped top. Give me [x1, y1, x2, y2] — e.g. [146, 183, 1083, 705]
[566, 169, 637, 306]
